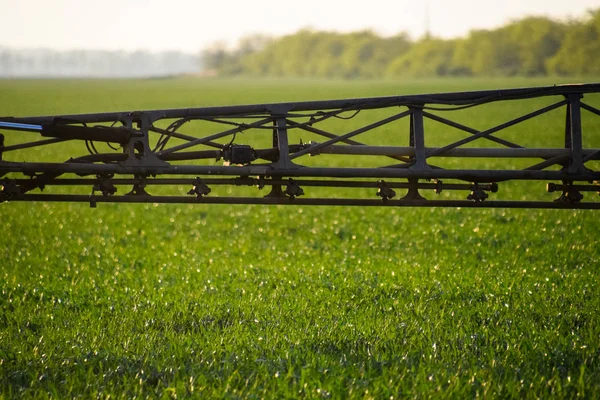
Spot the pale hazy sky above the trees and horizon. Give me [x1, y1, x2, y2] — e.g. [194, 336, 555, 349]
[0, 0, 600, 52]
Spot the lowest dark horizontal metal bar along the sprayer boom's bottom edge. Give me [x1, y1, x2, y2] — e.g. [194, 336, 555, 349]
[9, 194, 600, 210]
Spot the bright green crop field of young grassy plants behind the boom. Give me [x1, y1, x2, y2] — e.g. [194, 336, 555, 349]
[0, 78, 600, 399]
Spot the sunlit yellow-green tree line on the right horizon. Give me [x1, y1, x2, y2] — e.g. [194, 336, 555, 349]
[201, 9, 600, 79]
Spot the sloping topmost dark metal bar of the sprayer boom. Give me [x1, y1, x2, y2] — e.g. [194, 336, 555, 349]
[3, 83, 600, 124]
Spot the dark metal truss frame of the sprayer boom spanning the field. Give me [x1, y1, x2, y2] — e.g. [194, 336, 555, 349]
[0, 84, 600, 209]
